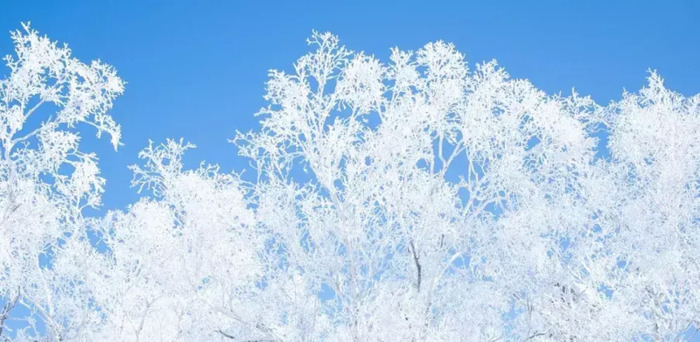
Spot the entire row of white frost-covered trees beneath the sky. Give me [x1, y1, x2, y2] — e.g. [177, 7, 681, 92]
[0, 25, 700, 341]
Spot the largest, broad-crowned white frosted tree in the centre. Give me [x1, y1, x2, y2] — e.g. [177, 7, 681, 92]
[232, 30, 599, 341]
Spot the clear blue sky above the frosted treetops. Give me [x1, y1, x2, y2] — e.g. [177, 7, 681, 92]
[0, 0, 700, 208]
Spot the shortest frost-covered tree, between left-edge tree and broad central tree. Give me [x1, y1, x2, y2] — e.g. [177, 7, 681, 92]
[92, 140, 264, 341]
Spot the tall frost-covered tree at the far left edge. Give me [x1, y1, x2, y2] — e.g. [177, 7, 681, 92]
[0, 25, 123, 340]
